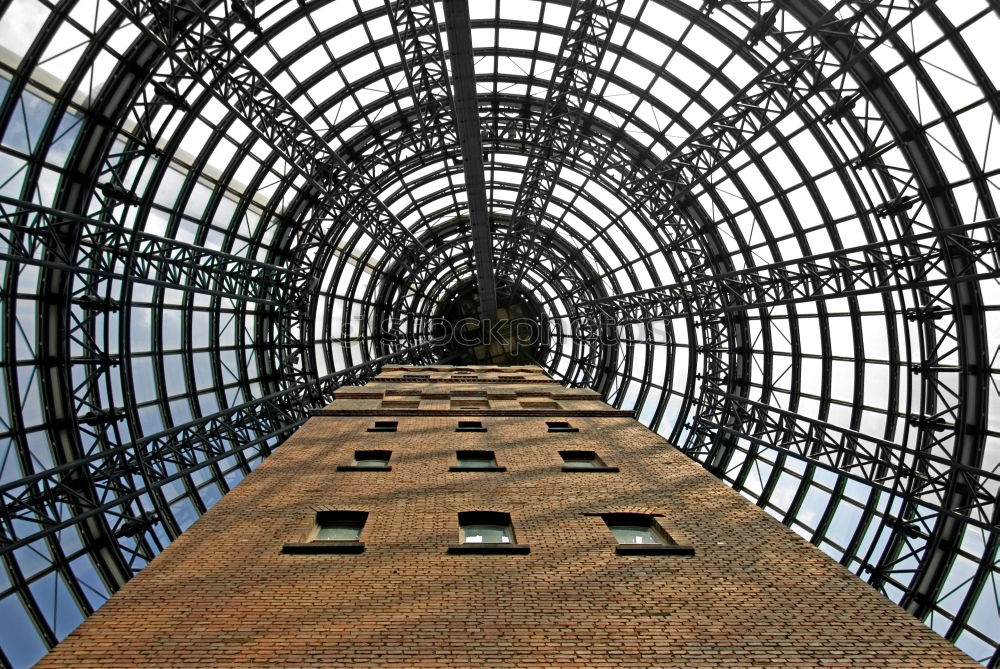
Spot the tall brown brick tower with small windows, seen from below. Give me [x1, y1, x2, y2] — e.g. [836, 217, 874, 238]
[39, 367, 978, 668]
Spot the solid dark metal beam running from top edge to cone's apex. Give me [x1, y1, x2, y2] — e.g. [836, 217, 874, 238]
[444, 0, 497, 321]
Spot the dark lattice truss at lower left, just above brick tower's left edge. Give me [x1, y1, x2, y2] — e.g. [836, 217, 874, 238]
[0, 342, 433, 557]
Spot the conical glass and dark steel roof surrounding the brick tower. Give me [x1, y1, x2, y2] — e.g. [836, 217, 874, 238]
[0, 0, 1000, 667]
